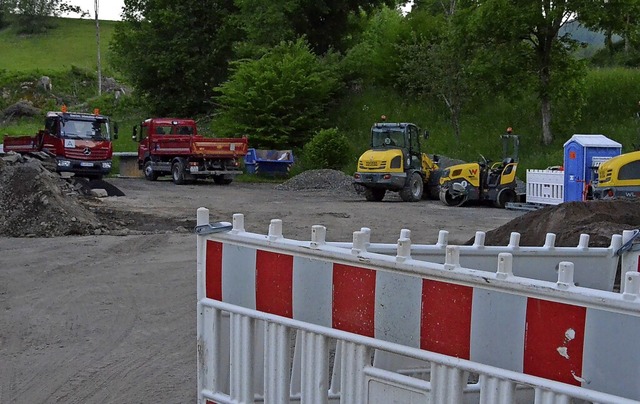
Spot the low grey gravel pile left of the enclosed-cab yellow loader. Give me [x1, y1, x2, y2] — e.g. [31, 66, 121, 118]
[276, 169, 356, 194]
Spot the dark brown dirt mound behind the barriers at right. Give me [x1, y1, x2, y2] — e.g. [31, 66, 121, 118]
[466, 199, 640, 247]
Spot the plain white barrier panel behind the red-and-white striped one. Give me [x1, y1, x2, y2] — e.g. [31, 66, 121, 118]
[328, 228, 622, 291]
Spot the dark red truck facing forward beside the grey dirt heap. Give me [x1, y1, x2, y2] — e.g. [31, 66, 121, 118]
[4, 107, 118, 179]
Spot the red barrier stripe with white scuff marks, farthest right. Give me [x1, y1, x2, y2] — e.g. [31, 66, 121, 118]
[523, 298, 587, 386]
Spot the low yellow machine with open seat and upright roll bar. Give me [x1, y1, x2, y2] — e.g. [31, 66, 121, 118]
[439, 128, 519, 208]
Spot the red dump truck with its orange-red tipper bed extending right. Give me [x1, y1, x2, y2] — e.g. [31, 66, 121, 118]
[133, 118, 248, 185]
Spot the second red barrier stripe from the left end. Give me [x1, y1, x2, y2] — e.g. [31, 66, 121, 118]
[256, 250, 293, 318]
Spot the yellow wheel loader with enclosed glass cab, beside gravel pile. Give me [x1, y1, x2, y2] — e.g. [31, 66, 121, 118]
[353, 117, 440, 202]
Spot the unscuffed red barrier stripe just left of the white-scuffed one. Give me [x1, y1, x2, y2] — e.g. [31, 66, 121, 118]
[420, 279, 473, 359]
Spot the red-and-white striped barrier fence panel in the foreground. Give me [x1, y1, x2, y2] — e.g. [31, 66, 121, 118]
[198, 213, 640, 403]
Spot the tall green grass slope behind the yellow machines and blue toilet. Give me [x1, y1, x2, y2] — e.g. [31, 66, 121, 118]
[331, 68, 640, 178]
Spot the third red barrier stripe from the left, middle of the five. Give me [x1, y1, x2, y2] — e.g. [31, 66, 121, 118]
[332, 263, 376, 337]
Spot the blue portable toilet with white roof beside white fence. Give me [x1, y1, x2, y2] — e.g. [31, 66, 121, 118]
[564, 135, 622, 202]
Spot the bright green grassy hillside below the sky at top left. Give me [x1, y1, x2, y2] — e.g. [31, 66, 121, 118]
[0, 18, 118, 72]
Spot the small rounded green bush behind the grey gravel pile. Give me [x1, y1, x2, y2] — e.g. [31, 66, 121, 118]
[302, 128, 351, 170]
